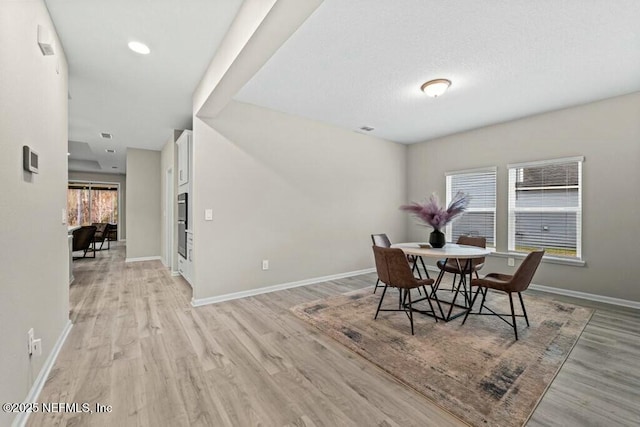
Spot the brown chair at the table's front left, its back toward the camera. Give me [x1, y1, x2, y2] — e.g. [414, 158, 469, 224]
[373, 245, 438, 335]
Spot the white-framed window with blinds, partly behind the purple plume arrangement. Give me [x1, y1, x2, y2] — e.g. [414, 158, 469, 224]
[446, 167, 496, 247]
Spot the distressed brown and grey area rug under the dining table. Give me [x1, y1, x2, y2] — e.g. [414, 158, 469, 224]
[291, 288, 593, 426]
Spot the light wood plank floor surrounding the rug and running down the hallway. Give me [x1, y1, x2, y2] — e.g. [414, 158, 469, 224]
[28, 247, 640, 426]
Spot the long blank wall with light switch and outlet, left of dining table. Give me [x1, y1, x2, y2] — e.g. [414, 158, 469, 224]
[193, 102, 406, 299]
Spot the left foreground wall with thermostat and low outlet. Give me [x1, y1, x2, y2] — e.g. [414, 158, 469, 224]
[0, 0, 69, 426]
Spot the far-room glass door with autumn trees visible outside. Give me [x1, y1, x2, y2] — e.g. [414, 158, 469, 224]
[67, 182, 119, 229]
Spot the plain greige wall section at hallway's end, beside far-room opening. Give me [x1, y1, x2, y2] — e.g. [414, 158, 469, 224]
[126, 148, 162, 259]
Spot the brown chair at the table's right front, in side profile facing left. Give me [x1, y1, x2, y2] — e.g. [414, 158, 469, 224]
[462, 250, 544, 341]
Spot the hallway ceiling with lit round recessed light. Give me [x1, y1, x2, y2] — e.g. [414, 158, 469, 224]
[46, 0, 242, 173]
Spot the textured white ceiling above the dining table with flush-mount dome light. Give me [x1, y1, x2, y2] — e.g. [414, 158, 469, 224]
[235, 0, 640, 143]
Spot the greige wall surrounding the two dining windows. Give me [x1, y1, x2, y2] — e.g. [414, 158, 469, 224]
[407, 93, 640, 301]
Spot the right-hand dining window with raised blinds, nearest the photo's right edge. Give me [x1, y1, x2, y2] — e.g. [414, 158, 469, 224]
[509, 157, 584, 259]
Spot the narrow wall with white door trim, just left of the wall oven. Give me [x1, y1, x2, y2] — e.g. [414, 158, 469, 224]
[159, 137, 178, 271]
